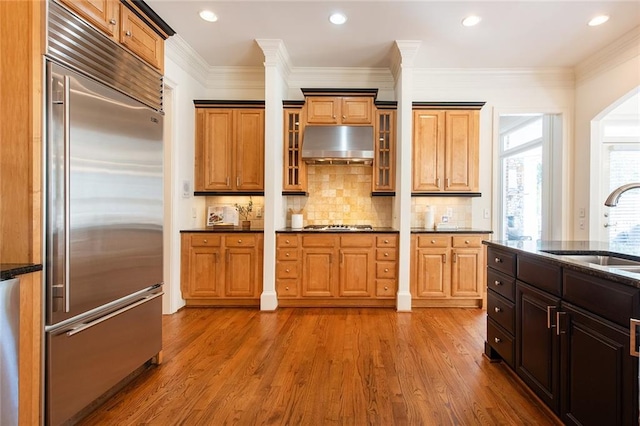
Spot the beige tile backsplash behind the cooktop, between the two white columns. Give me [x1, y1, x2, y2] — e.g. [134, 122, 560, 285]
[286, 164, 393, 227]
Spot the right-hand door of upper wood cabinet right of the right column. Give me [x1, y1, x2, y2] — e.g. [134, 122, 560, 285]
[445, 111, 478, 191]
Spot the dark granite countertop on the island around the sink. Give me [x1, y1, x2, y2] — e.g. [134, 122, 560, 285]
[484, 241, 640, 288]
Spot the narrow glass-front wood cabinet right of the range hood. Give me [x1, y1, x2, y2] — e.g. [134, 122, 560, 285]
[372, 108, 396, 194]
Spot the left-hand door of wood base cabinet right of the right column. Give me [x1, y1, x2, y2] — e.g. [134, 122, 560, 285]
[415, 249, 450, 297]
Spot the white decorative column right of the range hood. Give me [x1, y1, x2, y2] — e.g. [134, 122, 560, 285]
[391, 40, 422, 312]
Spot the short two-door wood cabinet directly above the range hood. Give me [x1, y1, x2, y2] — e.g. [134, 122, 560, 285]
[305, 96, 373, 125]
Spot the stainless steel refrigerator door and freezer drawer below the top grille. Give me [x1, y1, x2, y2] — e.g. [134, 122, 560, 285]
[45, 61, 163, 425]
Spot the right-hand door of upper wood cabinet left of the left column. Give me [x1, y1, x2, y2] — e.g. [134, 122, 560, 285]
[235, 109, 264, 190]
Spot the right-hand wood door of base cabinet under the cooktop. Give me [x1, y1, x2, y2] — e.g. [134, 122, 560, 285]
[340, 249, 374, 297]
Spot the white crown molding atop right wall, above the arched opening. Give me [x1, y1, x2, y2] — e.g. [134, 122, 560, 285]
[575, 26, 640, 83]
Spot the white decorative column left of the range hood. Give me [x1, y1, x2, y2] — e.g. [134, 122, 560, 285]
[256, 39, 290, 311]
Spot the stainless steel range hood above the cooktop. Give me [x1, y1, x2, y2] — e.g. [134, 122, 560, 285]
[302, 126, 373, 164]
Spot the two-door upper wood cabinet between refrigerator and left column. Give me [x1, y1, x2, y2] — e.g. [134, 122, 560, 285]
[194, 101, 264, 193]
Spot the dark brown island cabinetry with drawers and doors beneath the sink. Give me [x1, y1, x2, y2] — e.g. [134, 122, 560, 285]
[485, 247, 640, 425]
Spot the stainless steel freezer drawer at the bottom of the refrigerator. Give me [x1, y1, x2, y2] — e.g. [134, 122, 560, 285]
[46, 293, 162, 425]
